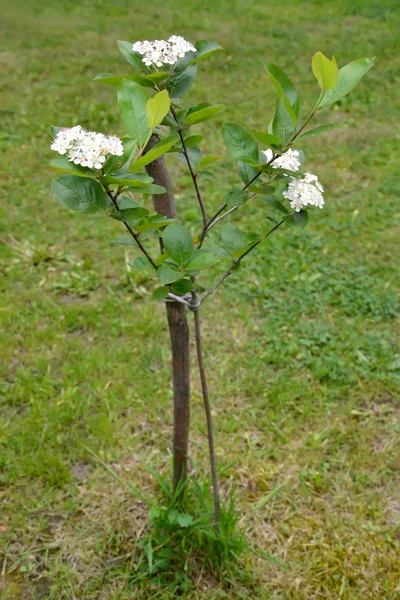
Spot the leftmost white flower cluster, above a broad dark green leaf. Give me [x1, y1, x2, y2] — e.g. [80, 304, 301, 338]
[51, 125, 124, 169]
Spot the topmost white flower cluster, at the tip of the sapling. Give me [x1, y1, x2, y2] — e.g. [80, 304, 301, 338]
[132, 35, 196, 67]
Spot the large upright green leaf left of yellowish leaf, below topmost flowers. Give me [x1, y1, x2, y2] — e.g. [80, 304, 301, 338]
[118, 79, 151, 147]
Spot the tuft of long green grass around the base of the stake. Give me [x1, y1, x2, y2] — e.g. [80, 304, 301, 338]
[86, 448, 278, 595]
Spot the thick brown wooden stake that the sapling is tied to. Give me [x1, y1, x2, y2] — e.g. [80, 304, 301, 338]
[146, 135, 190, 493]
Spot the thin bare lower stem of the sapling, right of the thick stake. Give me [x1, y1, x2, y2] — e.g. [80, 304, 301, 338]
[193, 310, 221, 533]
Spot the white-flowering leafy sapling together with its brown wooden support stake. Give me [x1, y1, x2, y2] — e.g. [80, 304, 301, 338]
[50, 36, 374, 530]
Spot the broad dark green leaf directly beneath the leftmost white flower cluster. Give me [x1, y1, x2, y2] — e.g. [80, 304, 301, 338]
[51, 175, 111, 215]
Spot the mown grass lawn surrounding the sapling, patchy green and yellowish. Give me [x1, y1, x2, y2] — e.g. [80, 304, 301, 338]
[0, 0, 400, 600]
